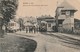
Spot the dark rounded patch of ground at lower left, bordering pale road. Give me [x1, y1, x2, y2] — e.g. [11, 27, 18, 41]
[0, 35, 37, 52]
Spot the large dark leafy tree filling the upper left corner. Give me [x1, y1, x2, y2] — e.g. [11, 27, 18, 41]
[0, 0, 18, 37]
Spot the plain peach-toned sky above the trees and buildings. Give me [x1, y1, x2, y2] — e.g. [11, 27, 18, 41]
[17, 0, 80, 19]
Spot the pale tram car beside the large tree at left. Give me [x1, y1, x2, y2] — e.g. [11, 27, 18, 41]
[7, 21, 19, 32]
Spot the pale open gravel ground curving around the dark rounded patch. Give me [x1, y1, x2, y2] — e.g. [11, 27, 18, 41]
[4, 32, 80, 52]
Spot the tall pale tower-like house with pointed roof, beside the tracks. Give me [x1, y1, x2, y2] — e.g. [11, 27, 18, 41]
[55, 1, 77, 30]
